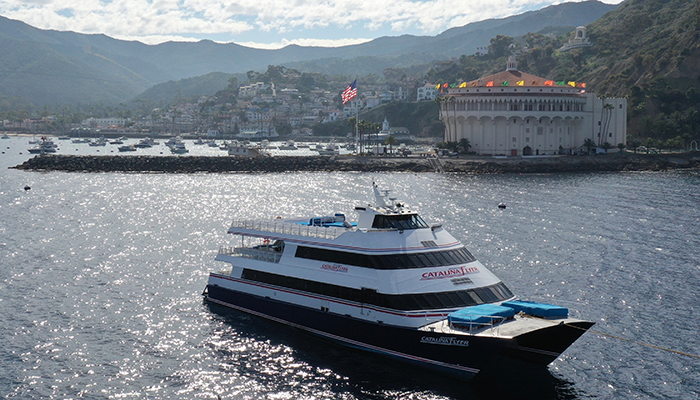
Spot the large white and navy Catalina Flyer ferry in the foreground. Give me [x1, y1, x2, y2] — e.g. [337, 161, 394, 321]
[204, 184, 593, 379]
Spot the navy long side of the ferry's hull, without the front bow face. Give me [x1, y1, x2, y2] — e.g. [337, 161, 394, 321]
[206, 274, 517, 380]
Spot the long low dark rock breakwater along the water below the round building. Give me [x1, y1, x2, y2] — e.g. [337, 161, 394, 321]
[12, 151, 700, 174]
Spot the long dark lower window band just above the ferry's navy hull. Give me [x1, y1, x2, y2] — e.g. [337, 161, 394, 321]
[241, 269, 513, 311]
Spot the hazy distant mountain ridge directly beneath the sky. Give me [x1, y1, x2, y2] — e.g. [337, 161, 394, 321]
[0, 1, 616, 106]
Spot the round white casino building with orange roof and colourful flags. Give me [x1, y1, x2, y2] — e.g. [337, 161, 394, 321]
[440, 56, 627, 156]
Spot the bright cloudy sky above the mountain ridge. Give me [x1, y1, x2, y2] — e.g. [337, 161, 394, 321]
[0, 0, 622, 49]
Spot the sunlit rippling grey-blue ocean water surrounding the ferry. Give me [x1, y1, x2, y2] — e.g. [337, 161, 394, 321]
[0, 138, 700, 400]
